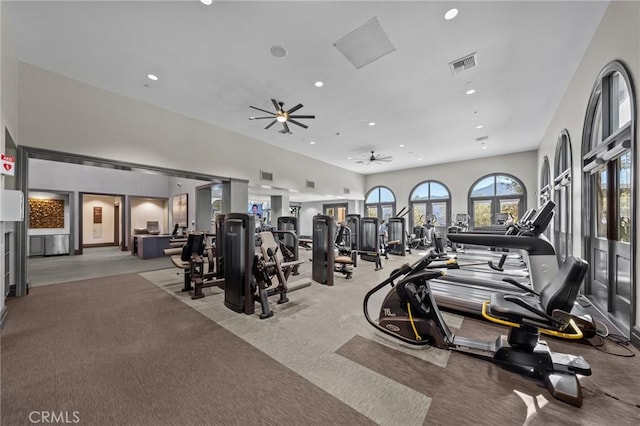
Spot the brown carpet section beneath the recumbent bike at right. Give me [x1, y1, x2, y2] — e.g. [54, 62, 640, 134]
[338, 318, 640, 425]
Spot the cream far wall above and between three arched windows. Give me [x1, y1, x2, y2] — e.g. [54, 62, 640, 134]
[365, 148, 538, 220]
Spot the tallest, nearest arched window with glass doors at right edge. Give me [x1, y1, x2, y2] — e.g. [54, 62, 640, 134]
[582, 61, 637, 337]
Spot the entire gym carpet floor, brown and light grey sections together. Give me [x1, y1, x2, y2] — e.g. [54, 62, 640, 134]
[1, 251, 640, 426]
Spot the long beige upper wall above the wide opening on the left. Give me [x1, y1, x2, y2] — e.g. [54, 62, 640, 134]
[19, 63, 364, 203]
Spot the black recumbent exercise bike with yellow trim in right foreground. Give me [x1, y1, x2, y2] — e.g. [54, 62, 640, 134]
[363, 253, 591, 407]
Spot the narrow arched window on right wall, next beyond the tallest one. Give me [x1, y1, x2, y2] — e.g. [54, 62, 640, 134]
[553, 130, 573, 262]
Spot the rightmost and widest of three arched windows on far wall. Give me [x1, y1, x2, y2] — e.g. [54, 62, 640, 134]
[469, 173, 527, 227]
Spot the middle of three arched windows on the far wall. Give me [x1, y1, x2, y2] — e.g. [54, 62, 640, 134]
[409, 180, 451, 229]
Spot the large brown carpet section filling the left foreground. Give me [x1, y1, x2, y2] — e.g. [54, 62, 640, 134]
[1, 275, 372, 425]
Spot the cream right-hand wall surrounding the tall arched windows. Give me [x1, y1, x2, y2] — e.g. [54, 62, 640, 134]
[537, 1, 640, 330]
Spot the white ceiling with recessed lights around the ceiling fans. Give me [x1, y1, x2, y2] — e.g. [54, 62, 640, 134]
[4, 0, 608, 174]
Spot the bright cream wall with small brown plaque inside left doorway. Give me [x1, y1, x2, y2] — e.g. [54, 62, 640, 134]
[82, 195, 120, 245]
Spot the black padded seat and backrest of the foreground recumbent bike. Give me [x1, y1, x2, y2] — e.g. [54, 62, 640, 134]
[487, 257, 589, 331]
